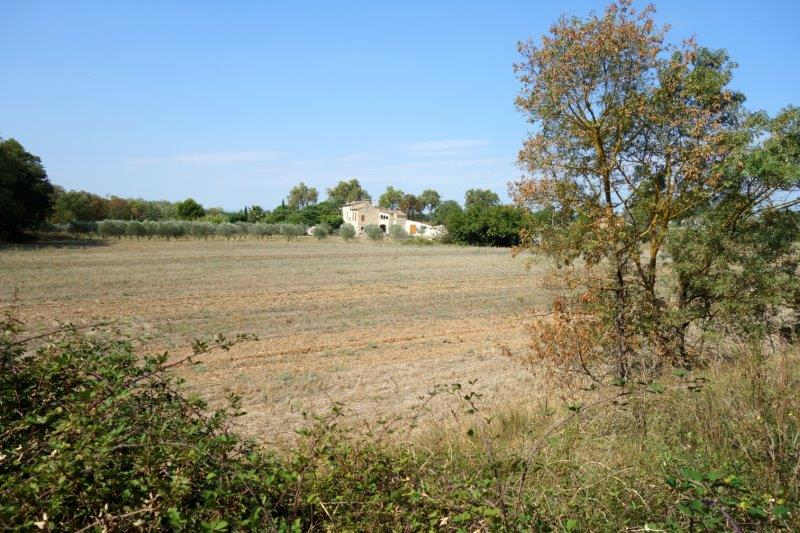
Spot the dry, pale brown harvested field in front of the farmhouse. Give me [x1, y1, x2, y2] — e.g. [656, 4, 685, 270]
[0, 238, 548, 443]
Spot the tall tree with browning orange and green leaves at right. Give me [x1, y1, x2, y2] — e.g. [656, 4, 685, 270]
[513, 0, 798, 382]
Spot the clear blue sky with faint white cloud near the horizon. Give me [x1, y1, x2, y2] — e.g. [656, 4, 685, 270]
[0, 0, 800, 209]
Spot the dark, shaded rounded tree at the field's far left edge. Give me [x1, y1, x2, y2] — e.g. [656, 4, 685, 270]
[0, 138, 53, 238]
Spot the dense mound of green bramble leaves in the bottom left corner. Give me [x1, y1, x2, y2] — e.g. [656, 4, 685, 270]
[0, 321, 292, 531]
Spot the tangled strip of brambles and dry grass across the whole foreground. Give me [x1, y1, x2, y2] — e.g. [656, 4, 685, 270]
[0, 319, 800, 532]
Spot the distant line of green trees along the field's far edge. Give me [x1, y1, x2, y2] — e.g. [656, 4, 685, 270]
[0, 143, 529, 246]
